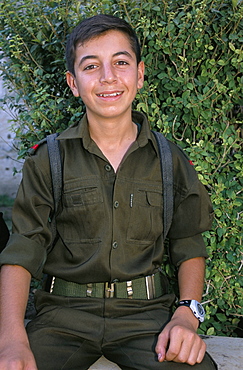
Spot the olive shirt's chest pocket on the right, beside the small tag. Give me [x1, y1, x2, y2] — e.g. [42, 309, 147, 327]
[127, 188, 163, 244]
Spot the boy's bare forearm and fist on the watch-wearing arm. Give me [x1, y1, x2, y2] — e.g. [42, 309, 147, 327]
[155, 257, 206, 365]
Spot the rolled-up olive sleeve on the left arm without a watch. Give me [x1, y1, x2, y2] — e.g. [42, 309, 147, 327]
[0, 149, 53, 279]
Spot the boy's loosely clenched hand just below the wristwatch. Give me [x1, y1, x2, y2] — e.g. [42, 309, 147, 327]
[155, 307, 206, 365]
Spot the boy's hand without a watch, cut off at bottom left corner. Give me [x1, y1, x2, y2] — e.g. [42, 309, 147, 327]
[0, 342, 37, 370]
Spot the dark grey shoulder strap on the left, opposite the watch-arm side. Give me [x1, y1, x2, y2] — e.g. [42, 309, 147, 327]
[46, 133, 62, 241]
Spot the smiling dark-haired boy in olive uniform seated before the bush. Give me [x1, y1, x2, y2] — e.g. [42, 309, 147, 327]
[0, 15, 215, 370]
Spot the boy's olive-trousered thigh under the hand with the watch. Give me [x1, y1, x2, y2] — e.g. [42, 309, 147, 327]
[102, 310, 217, 370]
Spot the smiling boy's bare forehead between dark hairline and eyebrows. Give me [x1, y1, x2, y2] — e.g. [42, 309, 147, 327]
[76, 30, 135, 55]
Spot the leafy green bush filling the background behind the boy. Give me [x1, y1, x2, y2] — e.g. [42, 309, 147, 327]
[0, 0, 243, 336]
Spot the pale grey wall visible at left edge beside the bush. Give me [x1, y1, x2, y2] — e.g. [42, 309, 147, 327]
[0, 78, 23, 198]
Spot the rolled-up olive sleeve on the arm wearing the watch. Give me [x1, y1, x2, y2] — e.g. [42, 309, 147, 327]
[168, 142, 214, 266]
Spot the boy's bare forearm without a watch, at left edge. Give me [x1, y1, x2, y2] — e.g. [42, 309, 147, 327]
[0, 265, 31, 338]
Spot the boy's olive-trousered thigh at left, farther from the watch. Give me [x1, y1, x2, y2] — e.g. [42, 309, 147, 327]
[27, 307, 103, 370]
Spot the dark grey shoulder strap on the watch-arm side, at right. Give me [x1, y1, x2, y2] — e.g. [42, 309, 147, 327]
[152, 131, 174, 240]
